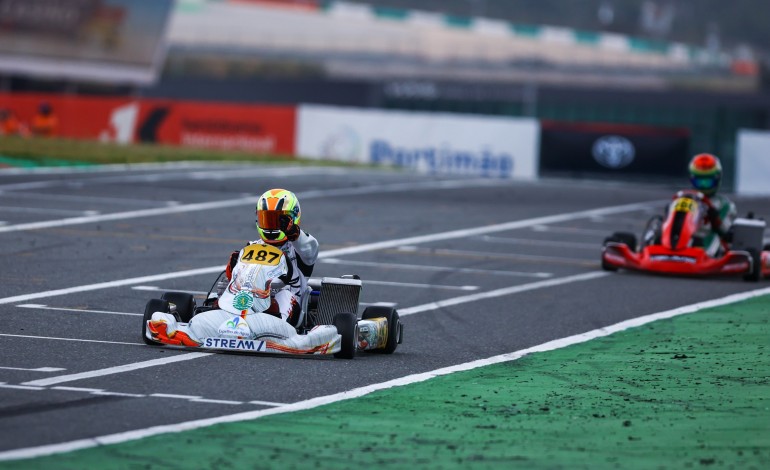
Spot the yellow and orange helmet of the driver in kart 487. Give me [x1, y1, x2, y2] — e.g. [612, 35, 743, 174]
[257, 189, 302, 245]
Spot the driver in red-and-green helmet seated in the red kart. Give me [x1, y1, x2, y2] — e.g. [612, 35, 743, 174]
[688, 153, 738, 257]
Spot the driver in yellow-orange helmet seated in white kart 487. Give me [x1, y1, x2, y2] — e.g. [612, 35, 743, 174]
[225, 189, 318, 326]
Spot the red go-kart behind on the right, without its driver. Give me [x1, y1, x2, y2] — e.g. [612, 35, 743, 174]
[602, 190, 770, 281]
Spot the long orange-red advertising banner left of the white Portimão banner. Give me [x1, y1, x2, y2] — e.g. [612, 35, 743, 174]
[0, 93, 296, 155]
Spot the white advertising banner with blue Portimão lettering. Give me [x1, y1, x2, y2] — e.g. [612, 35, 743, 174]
[296, 105, 540, 179]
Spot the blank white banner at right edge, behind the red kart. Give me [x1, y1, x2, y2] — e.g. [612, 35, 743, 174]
[735, 130, 770, 195]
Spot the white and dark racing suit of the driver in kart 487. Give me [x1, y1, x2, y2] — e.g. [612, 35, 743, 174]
[226, 229, 318, 326]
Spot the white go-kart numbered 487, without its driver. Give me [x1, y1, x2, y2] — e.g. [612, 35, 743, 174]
[142, 244, 404, 359]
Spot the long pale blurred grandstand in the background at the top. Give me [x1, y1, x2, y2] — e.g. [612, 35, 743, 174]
[169, 0, 757, 89]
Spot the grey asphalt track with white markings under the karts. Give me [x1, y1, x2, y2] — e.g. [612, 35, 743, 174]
[0, 165, 770, 458]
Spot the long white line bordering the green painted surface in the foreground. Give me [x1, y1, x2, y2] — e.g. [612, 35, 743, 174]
[0, 287, 770, 461]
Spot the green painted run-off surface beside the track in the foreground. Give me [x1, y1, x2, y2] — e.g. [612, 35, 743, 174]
[0, 297, 770, 469]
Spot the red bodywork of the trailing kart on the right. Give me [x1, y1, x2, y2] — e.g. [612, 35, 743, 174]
[602, 191, 770, 277]
